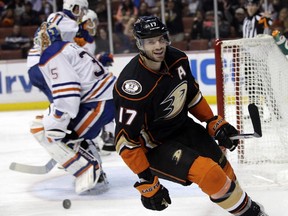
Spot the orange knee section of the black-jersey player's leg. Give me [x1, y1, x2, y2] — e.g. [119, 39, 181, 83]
[188, 156, 227, 196]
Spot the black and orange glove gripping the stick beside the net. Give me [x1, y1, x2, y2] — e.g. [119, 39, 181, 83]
[207, 116, 239, 151]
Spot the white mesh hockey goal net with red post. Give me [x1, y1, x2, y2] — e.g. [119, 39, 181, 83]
[215, 35, 288, 186]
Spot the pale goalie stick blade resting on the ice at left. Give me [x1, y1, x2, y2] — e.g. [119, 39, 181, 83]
[9, 159, 57, 174]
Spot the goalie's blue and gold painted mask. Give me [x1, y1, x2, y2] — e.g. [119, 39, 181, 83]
[34, 22, 62, 53]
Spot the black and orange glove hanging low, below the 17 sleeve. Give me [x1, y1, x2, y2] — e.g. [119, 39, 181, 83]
[134, 176, 171, 211]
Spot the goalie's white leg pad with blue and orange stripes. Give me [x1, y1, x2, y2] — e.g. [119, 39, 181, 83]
[31, 116, 105, 194]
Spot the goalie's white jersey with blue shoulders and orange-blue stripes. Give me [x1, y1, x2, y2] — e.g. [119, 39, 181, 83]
[39, 41, 116, 118]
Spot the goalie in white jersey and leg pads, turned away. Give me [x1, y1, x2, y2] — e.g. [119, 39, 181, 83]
[30, 23, 116, 193]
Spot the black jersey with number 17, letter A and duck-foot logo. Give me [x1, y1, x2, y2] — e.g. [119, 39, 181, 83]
[113, 46, 202, 173]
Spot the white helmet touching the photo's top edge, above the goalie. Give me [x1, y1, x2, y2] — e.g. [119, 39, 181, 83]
[63, 0, 88, 19]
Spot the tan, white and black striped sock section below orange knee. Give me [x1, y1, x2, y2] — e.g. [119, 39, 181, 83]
[210, 181, 251, 215]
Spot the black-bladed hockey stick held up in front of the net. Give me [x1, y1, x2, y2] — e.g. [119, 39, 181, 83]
[230, 104, 262, 140]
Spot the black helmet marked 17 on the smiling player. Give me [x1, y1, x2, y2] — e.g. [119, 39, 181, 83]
[133, 16, 171, 54]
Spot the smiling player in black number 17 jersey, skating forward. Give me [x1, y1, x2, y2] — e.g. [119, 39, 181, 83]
[113, 16, 266, 216]
